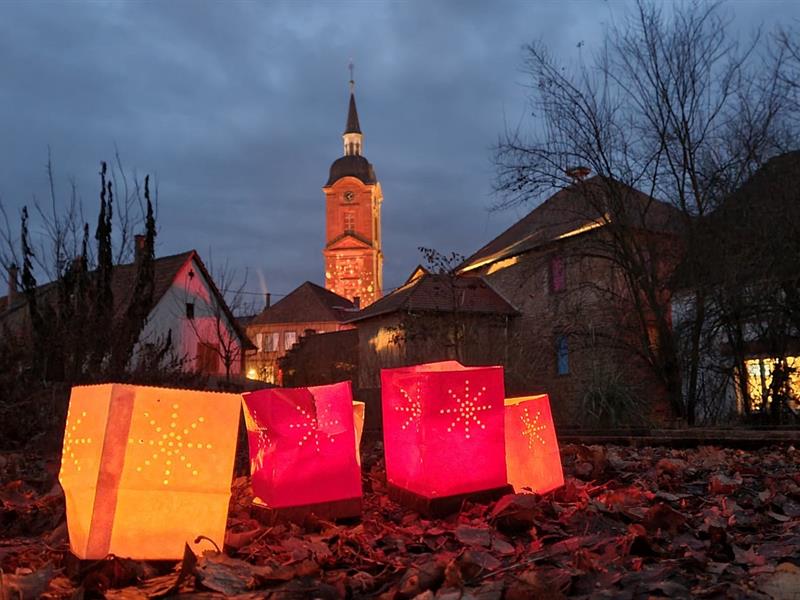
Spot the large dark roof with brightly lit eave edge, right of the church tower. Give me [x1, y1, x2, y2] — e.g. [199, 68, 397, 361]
[460, 176, 679, 271]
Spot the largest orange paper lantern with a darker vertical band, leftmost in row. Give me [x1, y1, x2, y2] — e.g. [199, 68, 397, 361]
[59, 384, 241, 559]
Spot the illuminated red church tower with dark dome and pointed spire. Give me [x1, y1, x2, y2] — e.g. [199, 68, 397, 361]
[322, 70, 383, 308]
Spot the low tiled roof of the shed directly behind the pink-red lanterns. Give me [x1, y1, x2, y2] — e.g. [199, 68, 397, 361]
[348, 273, 517, 322]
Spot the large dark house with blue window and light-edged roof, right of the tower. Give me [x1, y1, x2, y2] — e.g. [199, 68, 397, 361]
[457, 176, 681, 425]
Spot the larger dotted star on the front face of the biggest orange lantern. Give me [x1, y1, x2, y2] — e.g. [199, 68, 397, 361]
[128, 403, 212, 485]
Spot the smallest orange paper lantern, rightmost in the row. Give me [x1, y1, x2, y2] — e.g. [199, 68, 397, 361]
[505, 394, 564, 494]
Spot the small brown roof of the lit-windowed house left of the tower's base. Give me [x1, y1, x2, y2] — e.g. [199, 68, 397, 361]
[248, 281, 355, 325]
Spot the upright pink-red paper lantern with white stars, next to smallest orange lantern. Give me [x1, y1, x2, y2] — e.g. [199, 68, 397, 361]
[381, 361, 506, 498]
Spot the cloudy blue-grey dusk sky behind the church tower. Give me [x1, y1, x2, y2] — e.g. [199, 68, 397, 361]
[0, 0, 800, 310]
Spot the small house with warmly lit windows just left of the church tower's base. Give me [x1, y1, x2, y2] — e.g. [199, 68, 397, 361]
[245, 281, 358, 383]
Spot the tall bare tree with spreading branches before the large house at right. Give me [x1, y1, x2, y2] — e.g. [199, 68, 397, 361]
[496, 1, 789, 423]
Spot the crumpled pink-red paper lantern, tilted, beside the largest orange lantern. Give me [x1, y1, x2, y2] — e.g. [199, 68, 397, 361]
[243, 381, 361, 509]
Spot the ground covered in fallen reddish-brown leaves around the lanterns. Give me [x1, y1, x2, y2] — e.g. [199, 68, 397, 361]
[0, 445, 800, 600]
